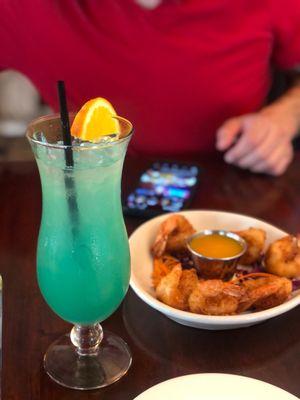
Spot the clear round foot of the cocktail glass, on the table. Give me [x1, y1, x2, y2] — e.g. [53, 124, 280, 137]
[44, 331, 132, 390]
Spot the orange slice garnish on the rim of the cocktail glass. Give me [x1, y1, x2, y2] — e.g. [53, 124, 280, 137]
[71, 97, 120, 143]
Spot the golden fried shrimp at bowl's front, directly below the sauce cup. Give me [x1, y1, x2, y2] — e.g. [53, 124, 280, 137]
[189, 279, 246, 315]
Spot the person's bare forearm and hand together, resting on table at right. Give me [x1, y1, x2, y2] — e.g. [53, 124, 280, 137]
[216, 68, 300, 175]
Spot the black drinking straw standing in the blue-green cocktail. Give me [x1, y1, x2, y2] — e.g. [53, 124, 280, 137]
[57, 81, 78, 227]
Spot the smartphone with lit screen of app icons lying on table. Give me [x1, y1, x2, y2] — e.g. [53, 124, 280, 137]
[123, 162, 200, 217]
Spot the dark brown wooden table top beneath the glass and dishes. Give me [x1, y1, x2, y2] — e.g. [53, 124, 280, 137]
[0, 154, 300, 400]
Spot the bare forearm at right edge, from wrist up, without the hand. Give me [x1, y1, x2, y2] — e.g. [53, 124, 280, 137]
[260, 70, 300, 137]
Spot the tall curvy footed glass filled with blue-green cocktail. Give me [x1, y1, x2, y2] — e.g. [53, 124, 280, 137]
[27, 115, 132, 390]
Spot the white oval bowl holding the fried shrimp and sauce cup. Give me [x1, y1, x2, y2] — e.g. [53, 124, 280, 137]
[129, 210, 300, 330]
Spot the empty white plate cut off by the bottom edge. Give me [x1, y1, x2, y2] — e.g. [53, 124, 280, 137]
[134, 374, 297, 400]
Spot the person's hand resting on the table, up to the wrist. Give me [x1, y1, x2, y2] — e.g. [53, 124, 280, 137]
[216, 112, 297, 175]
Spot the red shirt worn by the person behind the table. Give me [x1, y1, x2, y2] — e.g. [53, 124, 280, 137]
[0, 0, 300, 155]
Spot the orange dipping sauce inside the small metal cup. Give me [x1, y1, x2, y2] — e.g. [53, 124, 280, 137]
[190, 233, 243, 259]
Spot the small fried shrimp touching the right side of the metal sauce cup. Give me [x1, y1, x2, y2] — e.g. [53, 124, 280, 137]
[235, 228, 266, 265]
